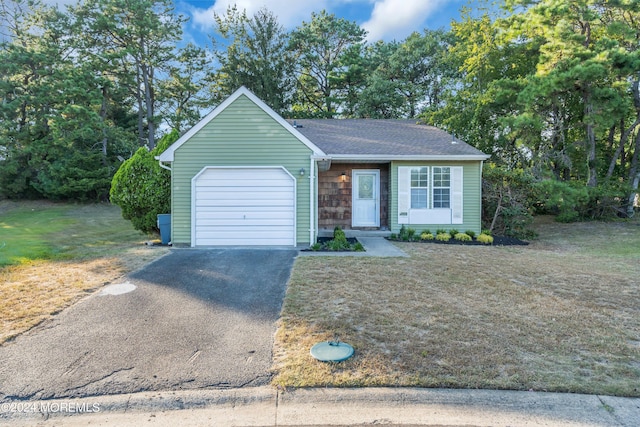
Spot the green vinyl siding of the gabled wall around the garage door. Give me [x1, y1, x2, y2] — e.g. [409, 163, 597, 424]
[171, 95, 312, 245]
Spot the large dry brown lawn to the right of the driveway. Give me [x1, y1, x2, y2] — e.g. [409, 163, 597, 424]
[274, 218, 640, 396]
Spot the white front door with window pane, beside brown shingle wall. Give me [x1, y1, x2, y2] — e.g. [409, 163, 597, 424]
[351, 169, 380, 227]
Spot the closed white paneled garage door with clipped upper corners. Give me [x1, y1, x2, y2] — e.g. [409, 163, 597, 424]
[192, 167, 295, 246]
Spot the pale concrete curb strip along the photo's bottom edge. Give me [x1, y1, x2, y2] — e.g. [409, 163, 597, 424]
[0, 386, 640, 427]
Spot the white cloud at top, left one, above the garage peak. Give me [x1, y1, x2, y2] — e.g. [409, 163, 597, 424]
[192, 0, 328, 29]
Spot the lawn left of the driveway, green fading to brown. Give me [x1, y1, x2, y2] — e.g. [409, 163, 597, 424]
[0, 201, 167, 344]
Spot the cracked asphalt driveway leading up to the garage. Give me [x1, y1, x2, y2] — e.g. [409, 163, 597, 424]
[0, 248, 297, 400]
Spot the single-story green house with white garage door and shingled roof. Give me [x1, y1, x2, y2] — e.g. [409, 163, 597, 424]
[157, 87, 489, 247]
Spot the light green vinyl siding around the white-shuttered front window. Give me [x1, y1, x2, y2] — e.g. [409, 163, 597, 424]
[389, 161, 482, 234]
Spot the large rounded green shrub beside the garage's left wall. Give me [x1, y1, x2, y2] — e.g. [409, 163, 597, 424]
[110, 130, 179, 233]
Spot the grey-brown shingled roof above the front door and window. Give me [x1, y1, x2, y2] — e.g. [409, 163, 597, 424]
[289, 119, 489, 160]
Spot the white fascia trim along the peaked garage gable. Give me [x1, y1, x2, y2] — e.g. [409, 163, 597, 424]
[157, 86, 324, 162]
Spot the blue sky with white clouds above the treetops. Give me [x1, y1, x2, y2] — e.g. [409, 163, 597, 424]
[176, 0, 476, 45]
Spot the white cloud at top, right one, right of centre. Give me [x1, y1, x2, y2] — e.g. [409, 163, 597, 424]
[362, 0, 450, 42]
